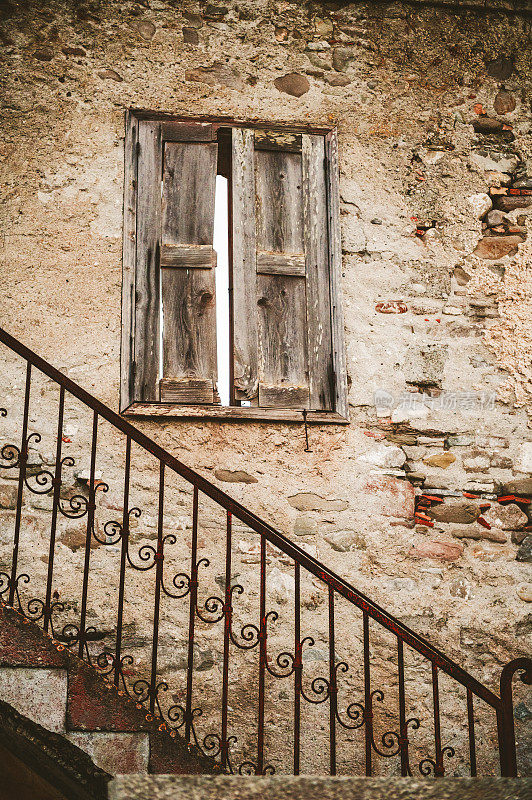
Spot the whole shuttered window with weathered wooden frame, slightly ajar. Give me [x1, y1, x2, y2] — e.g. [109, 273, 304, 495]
[121, 112, 347, 421]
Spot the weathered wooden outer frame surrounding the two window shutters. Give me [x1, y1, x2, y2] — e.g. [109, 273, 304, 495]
[120, 110, 349, 425]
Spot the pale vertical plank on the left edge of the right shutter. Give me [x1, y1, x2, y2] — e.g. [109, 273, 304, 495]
[231, 133, 258, 405]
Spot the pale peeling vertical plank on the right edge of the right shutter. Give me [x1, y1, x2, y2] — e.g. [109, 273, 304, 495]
[302, 135, 335, 410]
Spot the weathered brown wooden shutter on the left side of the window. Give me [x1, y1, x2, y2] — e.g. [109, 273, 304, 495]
[127, 120, 217, 403]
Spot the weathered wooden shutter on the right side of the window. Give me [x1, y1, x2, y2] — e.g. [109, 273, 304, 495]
[232, 129, 335, 410]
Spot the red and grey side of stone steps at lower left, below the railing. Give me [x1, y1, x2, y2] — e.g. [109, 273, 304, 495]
[0, 605, 220, 774]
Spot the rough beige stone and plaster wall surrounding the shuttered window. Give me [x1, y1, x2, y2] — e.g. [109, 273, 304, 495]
[0, 0, 532, 776]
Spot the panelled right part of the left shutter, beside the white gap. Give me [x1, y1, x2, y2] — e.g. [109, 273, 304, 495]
[161, 141, 217, 403]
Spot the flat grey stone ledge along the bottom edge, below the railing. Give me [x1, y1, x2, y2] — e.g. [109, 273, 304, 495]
[109, 775, 532, 800]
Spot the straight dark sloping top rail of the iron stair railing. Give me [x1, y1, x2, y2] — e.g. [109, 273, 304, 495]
[0, 328, 500, 709]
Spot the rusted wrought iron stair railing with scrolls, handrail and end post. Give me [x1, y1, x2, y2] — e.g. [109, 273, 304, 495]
[0, 329, 532, 776]
